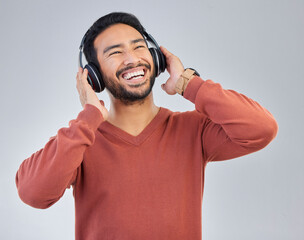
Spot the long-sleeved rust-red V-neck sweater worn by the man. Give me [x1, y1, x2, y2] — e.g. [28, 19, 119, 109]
[16, 77, 277, 240]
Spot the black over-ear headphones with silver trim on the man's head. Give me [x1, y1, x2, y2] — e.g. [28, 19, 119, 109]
[79, 29, 167, 92]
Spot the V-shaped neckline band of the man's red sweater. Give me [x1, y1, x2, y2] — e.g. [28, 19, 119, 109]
[99, 107, 170, 146]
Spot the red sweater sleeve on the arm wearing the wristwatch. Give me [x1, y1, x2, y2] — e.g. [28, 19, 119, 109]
[184, 77, 278, 161]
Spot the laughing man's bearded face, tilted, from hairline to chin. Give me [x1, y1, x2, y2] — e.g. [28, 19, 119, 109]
[94, 24, 155, 104]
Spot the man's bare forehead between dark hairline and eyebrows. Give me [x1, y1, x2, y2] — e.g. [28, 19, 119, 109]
[94, 23, 143, 51]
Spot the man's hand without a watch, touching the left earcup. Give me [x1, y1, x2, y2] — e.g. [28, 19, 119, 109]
[76, 67, 109, 120]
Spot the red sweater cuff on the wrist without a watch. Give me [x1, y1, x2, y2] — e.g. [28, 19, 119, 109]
[76, 104, 104, 131]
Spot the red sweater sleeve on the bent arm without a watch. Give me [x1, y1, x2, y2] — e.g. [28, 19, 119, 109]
[15, 104, 103, 208]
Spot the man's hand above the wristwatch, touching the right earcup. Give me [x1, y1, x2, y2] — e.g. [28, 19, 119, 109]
[160, 46, 185, 95]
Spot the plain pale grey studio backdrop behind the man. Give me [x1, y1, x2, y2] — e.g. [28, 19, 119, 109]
[0, 0, 304, 240]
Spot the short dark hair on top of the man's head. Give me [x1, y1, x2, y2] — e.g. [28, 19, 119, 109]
[83, 12, 145, 70]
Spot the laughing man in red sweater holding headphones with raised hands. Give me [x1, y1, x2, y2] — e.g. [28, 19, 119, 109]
[16, 13, 277, 240]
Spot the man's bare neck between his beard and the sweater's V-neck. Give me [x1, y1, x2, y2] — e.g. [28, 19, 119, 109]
[107, 92, 159, 136]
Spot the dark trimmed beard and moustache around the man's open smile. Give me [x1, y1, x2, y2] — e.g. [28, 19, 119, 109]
[103, 64, 155, 105]
